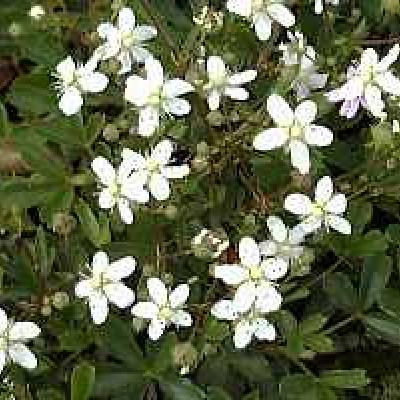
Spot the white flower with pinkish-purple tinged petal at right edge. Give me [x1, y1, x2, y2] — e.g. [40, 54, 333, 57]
[327, 44, 400, 119]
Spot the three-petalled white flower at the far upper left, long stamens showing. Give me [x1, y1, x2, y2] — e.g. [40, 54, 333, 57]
[54, 57, 108, 116]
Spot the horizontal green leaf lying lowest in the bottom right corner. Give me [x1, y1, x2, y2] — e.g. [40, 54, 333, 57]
[319, 368, 369, 389]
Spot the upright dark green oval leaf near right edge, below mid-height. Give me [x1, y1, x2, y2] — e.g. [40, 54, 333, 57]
[359, 255, 392, 310]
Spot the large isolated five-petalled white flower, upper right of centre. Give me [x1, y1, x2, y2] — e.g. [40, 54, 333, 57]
[253, 94, 333, 174]
